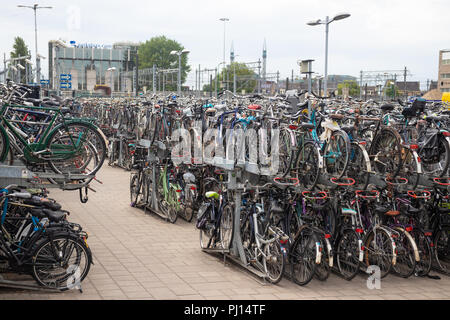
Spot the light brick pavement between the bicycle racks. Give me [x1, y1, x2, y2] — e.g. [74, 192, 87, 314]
[0, 166, 450, 300]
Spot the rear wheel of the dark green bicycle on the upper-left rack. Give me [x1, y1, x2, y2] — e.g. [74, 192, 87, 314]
[47, 122, 107, 175]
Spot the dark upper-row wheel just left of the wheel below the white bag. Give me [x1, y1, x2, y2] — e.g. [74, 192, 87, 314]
[291, 142, 321, 190]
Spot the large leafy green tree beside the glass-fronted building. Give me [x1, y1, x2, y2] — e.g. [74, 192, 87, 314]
[138, 36, 191, 91]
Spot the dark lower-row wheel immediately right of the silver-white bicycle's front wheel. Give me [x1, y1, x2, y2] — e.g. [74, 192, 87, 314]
[289, 228, 317, 286]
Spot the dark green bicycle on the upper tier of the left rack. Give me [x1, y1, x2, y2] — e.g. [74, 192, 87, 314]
[0, 104, 106, 175]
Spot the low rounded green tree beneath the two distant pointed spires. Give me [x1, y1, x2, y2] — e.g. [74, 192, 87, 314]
[203, 62, 257, 92]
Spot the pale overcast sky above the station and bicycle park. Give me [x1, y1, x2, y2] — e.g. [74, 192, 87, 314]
[0, 0, 450, 86]
